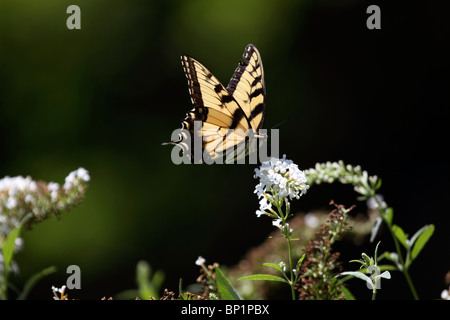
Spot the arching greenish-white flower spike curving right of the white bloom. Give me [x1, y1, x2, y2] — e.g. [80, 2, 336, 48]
[305, 161, 381, 199]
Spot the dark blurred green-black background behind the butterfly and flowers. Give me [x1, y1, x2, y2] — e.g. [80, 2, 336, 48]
[0, 0, 450, 299]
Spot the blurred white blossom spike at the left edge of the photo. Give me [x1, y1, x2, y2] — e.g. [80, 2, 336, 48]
[0, 168, 90, 272]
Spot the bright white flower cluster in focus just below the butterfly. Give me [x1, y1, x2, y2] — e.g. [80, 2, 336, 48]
[254, 155, 309, 217]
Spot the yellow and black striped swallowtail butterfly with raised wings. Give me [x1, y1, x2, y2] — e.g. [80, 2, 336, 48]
[171, 44, 266, 163]
